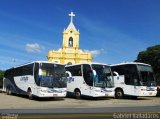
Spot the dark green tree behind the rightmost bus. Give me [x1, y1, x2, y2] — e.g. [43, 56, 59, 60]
[135, 45, 160, 85]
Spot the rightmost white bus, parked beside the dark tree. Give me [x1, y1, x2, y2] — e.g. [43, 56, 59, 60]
[111, 62, 157, 99]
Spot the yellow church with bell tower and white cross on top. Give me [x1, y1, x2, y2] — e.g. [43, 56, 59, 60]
[47, 12, 92, 64]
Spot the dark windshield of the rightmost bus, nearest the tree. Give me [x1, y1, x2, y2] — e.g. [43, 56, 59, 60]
[137, 65, 156, 86]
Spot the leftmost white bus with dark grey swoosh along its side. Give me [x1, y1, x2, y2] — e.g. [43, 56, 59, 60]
[3, 61, 67, 99]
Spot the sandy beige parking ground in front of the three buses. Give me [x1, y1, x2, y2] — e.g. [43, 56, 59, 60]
[0, 93, 160, 109]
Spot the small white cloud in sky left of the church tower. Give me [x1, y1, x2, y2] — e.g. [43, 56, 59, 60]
[26, 43, 44, 52]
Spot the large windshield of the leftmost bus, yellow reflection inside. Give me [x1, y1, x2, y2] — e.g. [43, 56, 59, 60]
[39, 63, 66, 88]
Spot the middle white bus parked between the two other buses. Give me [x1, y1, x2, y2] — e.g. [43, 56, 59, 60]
[65, 63, 115, 98]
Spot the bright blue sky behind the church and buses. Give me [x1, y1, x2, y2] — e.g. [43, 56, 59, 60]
[0, 0, 160, 69]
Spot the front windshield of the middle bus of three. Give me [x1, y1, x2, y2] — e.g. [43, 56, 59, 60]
[92, 64, 113, 87]
